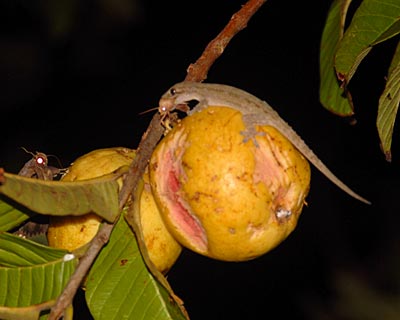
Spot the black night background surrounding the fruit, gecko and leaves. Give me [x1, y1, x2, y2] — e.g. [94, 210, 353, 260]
[0, 0, 400, 320]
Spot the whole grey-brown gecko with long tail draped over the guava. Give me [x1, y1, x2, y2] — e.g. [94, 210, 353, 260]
[158, 81, 371, 204]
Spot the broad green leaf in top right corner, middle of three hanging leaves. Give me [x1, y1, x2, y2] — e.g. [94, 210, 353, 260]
[335, 0, 400, 85]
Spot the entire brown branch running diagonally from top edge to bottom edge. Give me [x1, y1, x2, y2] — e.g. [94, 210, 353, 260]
[48, 0, 266, 320]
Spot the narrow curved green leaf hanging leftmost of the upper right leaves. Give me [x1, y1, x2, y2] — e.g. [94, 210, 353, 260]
[319, 0, 354, 116]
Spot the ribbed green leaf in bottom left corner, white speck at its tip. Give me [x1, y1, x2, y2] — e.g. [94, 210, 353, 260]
[0, 232, 78, 319]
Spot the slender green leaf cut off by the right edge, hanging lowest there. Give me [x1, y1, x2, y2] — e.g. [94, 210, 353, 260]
[376, 42, 400, 161]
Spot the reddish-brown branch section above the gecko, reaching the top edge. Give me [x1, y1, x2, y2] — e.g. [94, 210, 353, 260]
[185, 0, 267, 82]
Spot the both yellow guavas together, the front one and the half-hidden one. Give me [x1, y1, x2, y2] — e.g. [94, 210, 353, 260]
[48, 107, 310, 272]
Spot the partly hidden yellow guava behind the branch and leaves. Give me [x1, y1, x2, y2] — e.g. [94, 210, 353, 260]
[47, 147, 182, 272]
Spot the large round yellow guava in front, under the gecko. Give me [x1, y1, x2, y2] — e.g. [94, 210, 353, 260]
[150, 107, 310, 261]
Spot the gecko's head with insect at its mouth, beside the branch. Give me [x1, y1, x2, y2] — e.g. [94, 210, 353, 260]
[158, 82, 198, 115]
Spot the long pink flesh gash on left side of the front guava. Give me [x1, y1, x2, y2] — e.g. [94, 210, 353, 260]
[160, 151, 207, 252]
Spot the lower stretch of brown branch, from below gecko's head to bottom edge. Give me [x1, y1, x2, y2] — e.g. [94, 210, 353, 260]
[48, 113, 164, 320]
